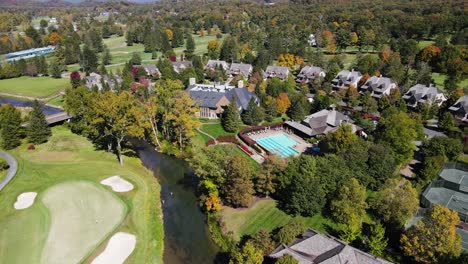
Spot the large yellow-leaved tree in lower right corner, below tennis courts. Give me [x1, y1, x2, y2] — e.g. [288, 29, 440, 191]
[400, 205, 461, 263]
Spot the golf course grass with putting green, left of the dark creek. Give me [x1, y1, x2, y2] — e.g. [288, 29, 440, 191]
[0, 126, 163, 263]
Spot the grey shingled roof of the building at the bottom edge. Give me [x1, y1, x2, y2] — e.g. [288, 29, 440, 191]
[269, 228, 391, 264]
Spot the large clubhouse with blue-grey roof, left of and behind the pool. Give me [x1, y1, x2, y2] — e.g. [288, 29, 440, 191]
[186, 84, 260, 119]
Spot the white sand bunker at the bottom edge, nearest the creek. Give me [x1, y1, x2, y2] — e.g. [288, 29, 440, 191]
[91, 232, 136, 264]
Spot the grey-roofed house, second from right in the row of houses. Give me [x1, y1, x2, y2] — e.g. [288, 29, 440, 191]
[402, 84, 447, 108]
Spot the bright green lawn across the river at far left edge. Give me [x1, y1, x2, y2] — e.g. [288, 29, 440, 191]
[0, 76, 70, 98]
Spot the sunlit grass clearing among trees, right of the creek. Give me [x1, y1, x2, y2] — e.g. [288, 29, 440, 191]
[221, 199, 336, 239]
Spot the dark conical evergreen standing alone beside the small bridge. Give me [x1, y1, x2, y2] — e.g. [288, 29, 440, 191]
[26, 100, 52, 144]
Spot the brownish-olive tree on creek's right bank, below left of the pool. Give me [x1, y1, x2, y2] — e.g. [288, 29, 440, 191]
[221, 156, 254, 207]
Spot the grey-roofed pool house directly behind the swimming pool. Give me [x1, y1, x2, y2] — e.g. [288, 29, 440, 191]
[286, 109, 363, 137]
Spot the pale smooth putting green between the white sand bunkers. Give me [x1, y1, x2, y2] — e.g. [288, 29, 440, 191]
[41, 181, 126, 264]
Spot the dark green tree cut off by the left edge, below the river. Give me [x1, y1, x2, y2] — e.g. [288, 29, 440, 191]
[0, 104, 21, 150]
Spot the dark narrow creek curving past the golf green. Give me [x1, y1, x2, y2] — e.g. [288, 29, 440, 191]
[135, 142, 219, 264]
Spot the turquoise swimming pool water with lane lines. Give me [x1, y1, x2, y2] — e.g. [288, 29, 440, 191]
[256, 134, 299, 158]
